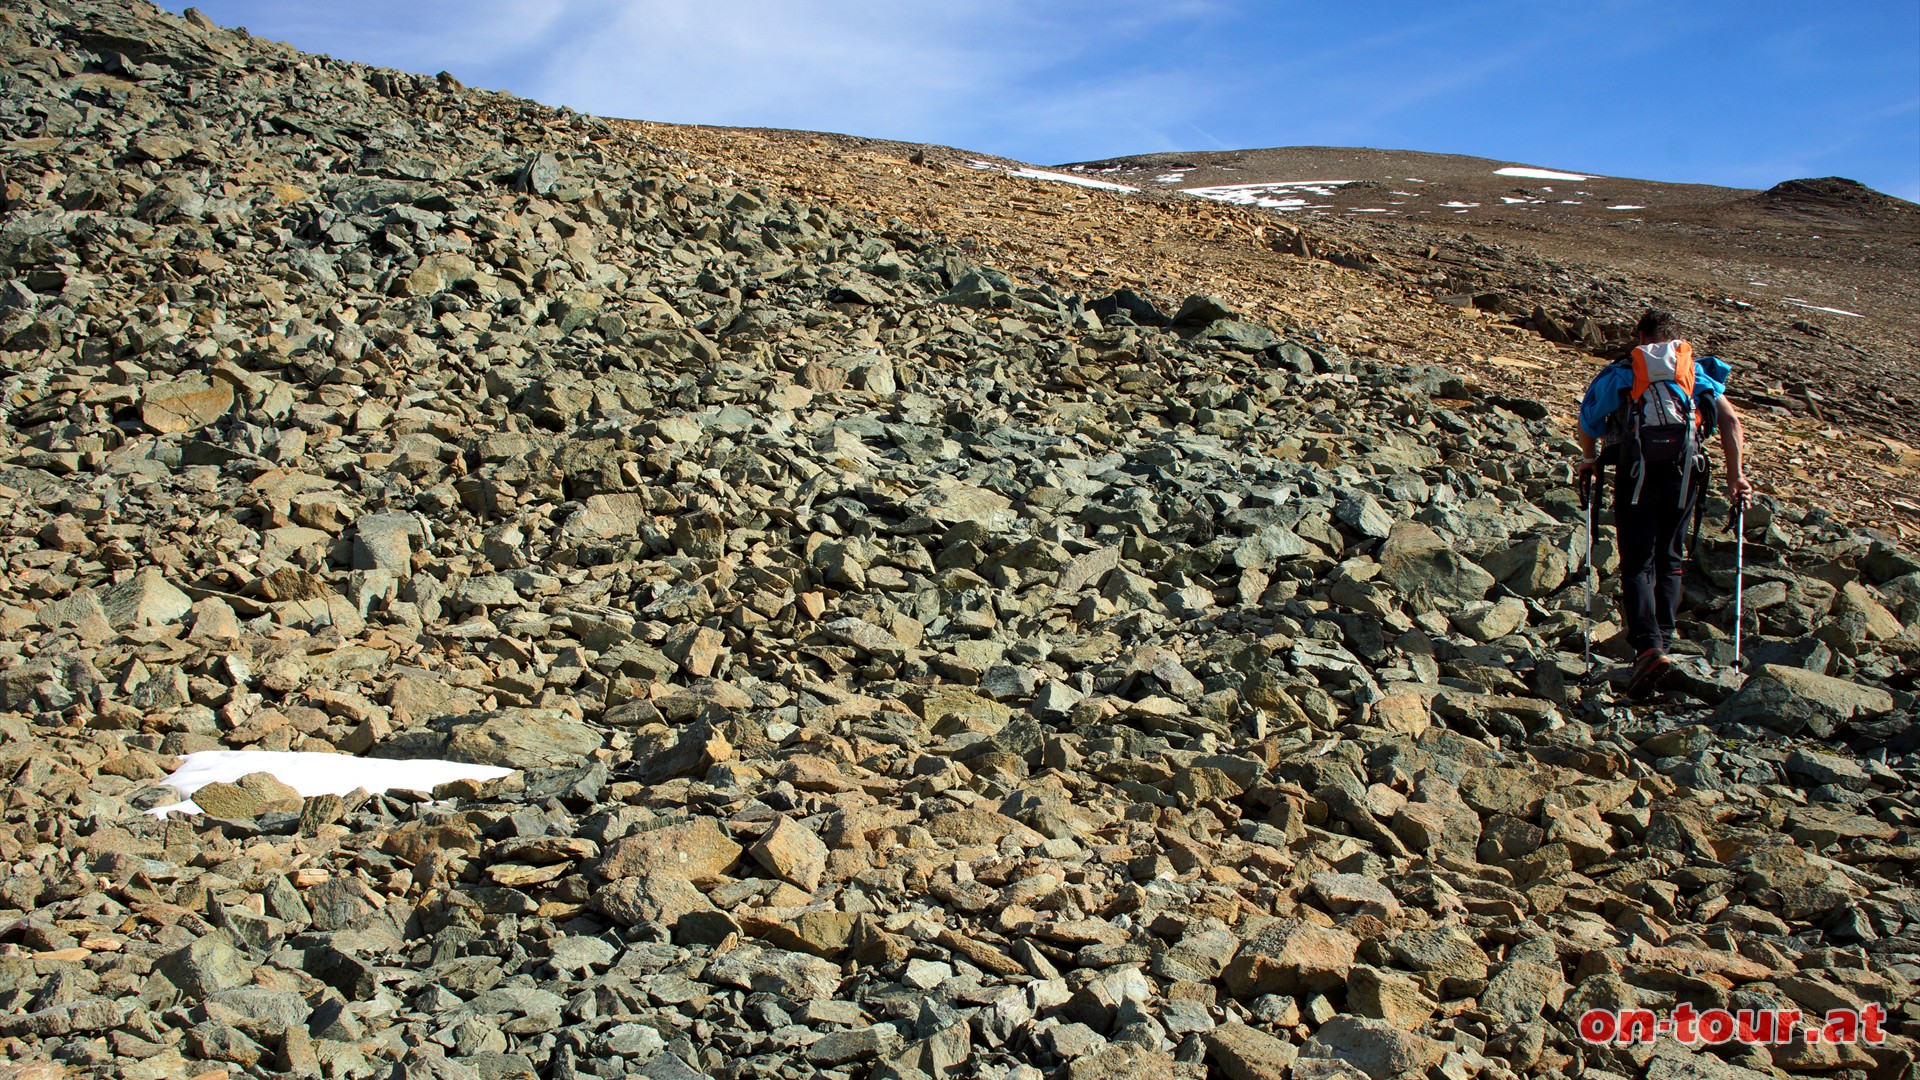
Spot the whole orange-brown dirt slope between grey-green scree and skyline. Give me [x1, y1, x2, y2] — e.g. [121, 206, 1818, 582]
[632, 123, 1920, 536]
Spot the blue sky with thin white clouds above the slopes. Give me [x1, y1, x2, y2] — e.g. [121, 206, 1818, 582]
[163, 0, 1920, 202]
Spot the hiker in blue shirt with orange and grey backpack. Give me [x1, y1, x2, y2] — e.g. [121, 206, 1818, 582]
[1576, 309, 1753, 698]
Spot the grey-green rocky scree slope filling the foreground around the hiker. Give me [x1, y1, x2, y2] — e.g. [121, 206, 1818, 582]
[0, 2, 1920, 1080]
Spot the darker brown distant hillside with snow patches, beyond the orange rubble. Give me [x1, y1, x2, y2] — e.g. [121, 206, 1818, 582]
[1062, 146, 1920, 521]
